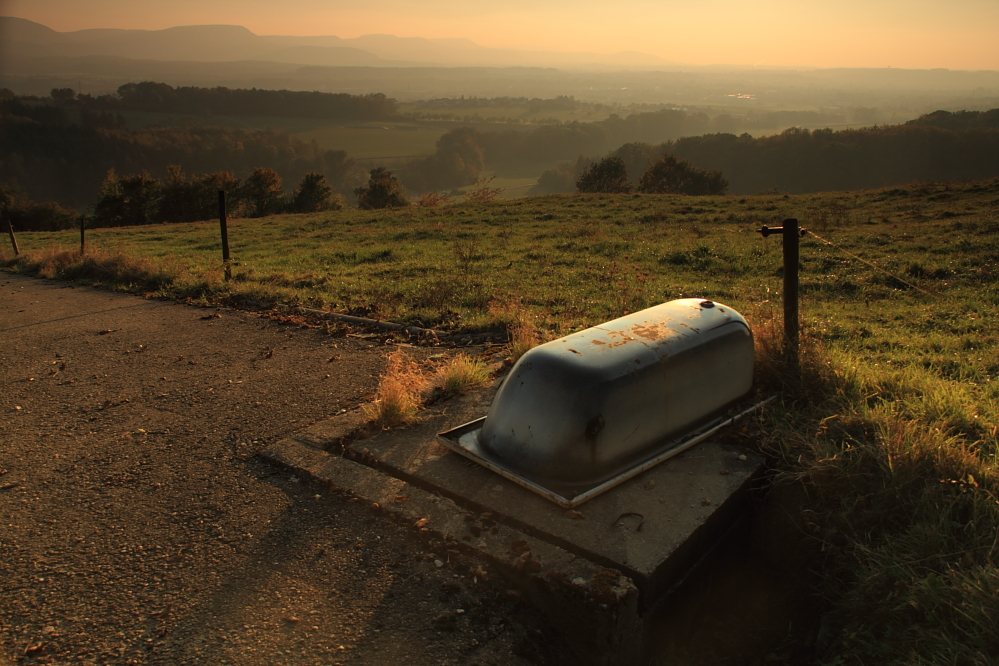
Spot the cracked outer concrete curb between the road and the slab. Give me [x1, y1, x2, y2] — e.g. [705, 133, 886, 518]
[261, 426, 642, 666]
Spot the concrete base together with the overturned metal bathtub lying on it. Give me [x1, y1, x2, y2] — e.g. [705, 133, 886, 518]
[265, 299, 796, 665]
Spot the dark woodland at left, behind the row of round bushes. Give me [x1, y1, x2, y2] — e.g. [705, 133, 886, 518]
[0, 91, 366, 209]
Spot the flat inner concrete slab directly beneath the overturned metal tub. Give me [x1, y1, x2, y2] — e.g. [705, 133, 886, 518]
[349, 390, 763, 600]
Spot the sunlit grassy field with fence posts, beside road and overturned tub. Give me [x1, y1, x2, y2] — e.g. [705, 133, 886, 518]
[0, 181, 999, 664]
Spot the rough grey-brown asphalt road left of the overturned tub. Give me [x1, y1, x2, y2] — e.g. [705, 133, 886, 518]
[0, 273, 552, 666]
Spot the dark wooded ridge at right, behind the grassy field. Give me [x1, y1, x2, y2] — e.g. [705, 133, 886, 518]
[532, 109, 999, 194]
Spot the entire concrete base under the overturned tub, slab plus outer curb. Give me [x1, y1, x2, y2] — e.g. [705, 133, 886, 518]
[264, 382, 763, 665]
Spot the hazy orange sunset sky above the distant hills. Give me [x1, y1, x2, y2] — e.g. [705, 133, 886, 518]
[7, 0, 999, 69]
